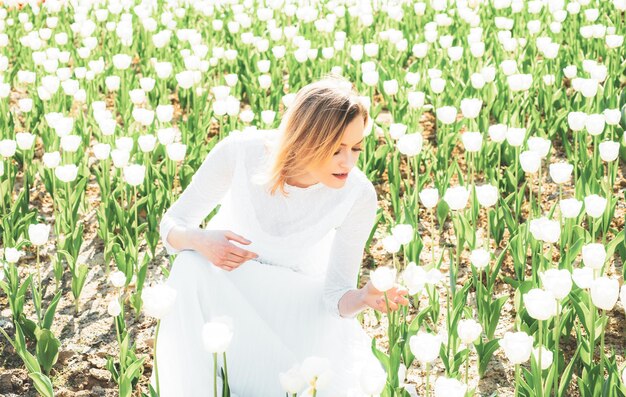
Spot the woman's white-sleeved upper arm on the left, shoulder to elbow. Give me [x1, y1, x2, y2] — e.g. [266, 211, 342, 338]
[159, 135, 237, 255]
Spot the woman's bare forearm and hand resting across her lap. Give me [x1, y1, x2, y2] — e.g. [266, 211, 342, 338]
[193, 229, 259, 272]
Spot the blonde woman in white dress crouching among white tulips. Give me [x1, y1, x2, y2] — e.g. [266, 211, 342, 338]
[156, 77, 408, 397]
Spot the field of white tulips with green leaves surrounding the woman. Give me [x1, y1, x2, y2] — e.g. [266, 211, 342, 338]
[0, 0, 626, 397]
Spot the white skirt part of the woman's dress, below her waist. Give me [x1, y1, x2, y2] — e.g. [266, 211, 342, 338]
[151, 251, 376, 397]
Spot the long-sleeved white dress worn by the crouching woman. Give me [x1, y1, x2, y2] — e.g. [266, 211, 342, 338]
[152, 130, 377, 397]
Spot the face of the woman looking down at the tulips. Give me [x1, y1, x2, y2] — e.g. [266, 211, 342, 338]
[290, 116, 365, 189]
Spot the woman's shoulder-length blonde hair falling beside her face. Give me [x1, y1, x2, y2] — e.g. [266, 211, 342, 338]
[255, 75, 369, 196]
